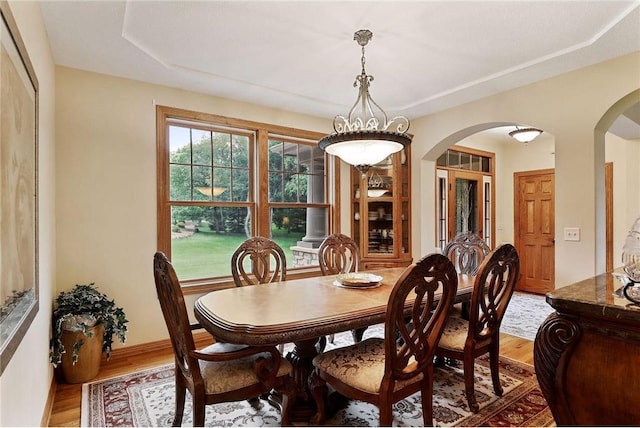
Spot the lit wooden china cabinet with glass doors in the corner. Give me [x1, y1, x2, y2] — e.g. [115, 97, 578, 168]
[351, 147, 412, 270]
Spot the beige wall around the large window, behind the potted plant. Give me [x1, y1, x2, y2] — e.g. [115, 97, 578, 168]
[56, 67, 332, 347]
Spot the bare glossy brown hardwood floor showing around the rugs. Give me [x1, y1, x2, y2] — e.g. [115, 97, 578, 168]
[49, 334, 533, 427]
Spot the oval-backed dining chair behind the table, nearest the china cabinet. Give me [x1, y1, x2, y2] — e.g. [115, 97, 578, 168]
[318, 233, 366, 343]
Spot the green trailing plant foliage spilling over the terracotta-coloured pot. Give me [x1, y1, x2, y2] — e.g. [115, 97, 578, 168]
[49, 282, 128, 367]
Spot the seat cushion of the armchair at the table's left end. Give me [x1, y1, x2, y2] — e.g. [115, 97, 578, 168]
[199, 343, 292, 394]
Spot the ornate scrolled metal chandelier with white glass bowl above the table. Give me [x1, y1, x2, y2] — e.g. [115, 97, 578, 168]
[318, 30, 411, 175]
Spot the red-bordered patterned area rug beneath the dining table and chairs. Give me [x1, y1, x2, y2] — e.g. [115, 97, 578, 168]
[81, 326, 553, 427]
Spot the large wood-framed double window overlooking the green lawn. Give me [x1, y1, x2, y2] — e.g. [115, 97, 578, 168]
[157, 106, 338, 287]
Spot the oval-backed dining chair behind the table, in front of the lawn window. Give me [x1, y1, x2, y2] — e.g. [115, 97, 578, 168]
[231, 236, 287, 287]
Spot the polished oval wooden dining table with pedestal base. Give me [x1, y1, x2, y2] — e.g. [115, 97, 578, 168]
[194, 268, 474, 421]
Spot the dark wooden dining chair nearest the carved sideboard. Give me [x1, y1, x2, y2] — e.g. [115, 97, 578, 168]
[436, 244, 520, 413]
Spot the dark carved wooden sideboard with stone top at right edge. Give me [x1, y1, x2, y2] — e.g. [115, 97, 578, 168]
[534, 273, 640, 426]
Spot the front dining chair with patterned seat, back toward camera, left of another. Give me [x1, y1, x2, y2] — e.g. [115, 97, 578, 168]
[309, 254, 458, 425]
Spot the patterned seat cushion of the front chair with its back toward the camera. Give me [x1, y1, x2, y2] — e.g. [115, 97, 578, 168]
[313, 338, 422, 394]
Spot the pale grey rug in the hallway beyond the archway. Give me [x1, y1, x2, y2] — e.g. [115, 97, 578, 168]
[500, 291, 553, 340]
